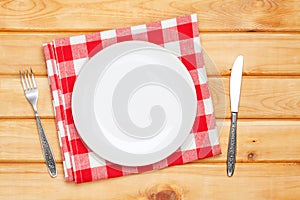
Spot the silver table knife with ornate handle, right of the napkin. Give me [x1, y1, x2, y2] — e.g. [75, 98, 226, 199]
[227, 55, 244, 177]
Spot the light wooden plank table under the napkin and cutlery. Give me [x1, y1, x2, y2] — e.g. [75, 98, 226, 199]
[0, 0, 300, 200]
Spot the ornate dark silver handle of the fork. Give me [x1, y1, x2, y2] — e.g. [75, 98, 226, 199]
[35, 111, 57, 178]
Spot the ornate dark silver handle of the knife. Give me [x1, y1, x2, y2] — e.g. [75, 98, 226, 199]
[227, 112, 237, 177]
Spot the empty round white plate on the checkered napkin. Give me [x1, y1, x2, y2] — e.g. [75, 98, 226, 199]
[72, 41, 197, 166]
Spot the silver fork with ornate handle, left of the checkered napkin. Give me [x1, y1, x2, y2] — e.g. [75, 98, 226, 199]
[20, 68, 57, 177]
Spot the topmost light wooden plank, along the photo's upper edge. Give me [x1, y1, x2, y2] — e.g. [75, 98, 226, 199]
[0, 0, 300, 31]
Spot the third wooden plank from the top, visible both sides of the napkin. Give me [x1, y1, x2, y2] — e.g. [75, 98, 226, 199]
[0, 75, 300, 118]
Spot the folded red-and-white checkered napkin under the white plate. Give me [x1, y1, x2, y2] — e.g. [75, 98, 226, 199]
[43, 14, 221, 183]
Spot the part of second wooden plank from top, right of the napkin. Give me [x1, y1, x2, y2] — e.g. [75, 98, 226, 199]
[200, 33, 300, 76]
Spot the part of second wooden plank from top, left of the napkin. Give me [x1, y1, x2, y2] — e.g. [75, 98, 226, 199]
[0, 33, 68, 75]
